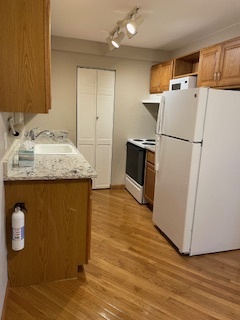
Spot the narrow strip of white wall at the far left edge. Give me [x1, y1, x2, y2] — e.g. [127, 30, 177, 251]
[0, 112, 10, 316]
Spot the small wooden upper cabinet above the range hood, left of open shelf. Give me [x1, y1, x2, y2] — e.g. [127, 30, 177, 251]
[150, 60, 173, 93]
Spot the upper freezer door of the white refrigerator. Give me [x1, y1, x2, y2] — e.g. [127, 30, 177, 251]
[161, 88, 209, 142]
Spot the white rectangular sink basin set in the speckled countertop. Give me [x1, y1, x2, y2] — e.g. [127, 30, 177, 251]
[34, 143, 78, 155]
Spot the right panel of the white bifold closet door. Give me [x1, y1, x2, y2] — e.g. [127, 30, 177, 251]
[95, 70, 115, 188]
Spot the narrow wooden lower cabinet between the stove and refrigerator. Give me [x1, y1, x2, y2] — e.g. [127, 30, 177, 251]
[144, 150, 155, 205]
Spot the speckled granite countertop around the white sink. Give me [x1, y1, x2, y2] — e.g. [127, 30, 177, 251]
[3, 136, 97, 181]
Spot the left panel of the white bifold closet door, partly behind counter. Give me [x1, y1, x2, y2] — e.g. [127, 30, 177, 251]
[77, 68, 97, 168]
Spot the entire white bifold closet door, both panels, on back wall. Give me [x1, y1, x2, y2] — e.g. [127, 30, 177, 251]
[77, 68, 115, 189]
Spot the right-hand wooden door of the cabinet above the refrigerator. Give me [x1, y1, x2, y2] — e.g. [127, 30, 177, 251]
[218, 39, 240, 86]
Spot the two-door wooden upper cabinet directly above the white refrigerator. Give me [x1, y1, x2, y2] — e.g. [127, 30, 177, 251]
[198, 38, 240, 87]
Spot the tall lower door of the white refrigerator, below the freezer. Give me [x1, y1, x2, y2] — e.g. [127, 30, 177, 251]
[153, 136, 201, 253]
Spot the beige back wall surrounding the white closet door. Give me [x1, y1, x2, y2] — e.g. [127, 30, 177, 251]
[25, 39, 161, 185]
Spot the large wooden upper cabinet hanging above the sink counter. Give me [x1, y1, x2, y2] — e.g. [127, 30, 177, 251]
[0, 0, 51, 113]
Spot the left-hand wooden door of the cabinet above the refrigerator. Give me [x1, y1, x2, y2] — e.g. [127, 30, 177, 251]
[198, 45, 221, 87]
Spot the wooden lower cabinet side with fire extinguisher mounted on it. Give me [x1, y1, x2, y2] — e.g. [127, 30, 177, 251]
[5, 179, 91, 287]
